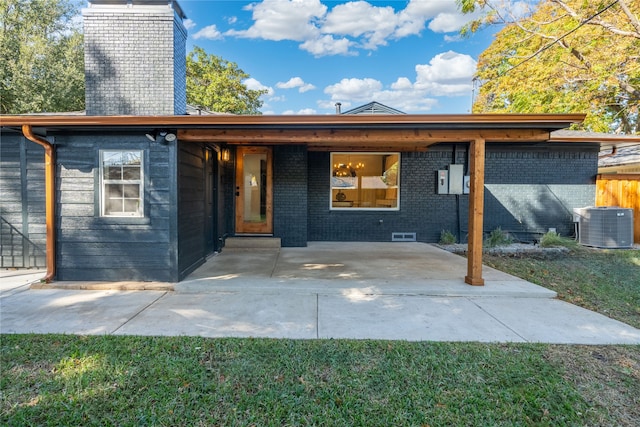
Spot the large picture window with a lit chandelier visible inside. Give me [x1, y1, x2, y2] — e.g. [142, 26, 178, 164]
[331, 153, 400, 210]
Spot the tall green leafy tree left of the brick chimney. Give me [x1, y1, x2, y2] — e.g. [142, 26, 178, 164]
[0, 0, 84, 114]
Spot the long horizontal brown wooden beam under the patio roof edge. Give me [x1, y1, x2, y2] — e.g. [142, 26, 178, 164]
[178, 128, 549, 146]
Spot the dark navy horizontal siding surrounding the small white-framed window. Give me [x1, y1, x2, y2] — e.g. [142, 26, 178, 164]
[56, 132, 178, 281]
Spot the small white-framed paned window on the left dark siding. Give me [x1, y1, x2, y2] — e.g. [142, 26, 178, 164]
[100, 150, 144, 217]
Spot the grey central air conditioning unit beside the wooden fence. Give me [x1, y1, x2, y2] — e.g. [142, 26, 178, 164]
[573, 207, 633, 248]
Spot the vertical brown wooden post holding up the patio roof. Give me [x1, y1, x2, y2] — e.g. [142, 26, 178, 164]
[464, 138, 485, 286]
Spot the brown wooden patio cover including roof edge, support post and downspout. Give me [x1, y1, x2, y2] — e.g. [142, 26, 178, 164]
[0, 114, 585, 286]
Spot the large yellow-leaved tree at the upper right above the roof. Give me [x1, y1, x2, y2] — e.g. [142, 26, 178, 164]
[458, 0, 640, 134]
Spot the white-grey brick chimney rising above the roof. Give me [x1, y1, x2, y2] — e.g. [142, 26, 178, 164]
[82, 0, 187, 116]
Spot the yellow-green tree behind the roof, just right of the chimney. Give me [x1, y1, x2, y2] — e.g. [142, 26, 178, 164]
[187, 46, 267, 114]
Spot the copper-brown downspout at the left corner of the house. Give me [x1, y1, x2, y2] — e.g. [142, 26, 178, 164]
[22, 125, 56, 283]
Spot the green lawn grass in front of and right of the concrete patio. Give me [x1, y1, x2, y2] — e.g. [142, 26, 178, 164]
[0, 249, 640, 426]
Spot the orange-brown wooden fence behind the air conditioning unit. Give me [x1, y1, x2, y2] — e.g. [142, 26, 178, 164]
[596, 174, 640, 243]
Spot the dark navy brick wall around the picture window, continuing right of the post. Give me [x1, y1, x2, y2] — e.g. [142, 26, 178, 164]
[307, 144, 598, 242]
